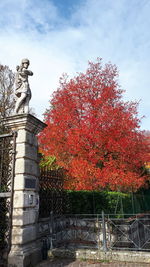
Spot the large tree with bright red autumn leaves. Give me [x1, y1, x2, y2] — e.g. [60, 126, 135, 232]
[39, 59, 149, 190]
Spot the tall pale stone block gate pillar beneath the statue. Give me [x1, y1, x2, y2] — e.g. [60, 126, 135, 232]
[4, 114, 46, 267]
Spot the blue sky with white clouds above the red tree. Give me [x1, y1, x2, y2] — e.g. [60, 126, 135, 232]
[0, 0, 150, 130]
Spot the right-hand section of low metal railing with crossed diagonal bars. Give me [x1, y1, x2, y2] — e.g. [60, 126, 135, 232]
[106, 214, 150, 251]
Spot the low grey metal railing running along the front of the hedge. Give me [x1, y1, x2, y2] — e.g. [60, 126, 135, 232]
[50, 213, 150, 251]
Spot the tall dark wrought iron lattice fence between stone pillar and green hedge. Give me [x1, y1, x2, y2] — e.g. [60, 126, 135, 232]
[39, 167, 66, 218]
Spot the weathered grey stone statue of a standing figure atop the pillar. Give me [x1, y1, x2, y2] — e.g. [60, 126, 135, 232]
[15, 58, 33, 114]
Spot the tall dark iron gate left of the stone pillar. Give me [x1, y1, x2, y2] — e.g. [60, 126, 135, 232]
[0, 132, 16, 266]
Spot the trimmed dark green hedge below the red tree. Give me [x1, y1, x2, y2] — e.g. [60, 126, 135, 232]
[66, 190, 150, 214]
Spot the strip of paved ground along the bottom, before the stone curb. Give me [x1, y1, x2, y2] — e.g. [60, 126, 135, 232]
[36, 259, 150, 267]
